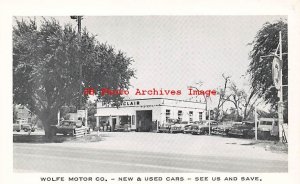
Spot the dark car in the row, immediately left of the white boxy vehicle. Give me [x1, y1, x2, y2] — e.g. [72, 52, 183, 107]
[227, 121, 255, 138]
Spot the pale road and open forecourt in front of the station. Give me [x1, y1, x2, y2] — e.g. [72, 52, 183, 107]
[13, 133, 288, 173]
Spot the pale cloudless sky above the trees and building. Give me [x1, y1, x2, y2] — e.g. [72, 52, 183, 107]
[15, 16, 286, 108]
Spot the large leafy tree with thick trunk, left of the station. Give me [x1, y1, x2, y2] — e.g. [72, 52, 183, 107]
[13, 19, 134, 138]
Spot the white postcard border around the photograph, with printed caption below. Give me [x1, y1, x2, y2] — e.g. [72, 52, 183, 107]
[0, 0, 300, 184]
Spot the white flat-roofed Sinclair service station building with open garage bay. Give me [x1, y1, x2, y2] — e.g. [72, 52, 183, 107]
[95, 98, 205, 132]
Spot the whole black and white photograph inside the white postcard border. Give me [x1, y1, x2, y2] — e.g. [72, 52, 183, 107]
[12, 16, 288, 173]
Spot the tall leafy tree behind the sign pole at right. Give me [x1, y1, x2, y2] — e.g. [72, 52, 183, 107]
[248, 20, 288, 122]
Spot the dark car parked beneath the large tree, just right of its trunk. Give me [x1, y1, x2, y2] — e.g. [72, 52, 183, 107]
[54, 120, 87, 136]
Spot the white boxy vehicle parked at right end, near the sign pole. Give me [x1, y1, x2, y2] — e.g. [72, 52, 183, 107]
[257, 118, 279, 139]
